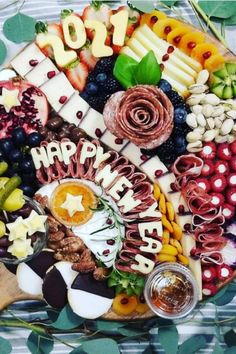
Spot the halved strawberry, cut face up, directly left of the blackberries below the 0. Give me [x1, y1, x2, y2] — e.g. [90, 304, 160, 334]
[65, 61, 88, 92]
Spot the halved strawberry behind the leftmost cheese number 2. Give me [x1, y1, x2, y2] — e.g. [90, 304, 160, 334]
[35, 21, 64, 59]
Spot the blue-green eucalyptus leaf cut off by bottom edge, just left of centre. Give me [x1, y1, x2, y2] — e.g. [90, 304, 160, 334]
[82, 338, 120, 354]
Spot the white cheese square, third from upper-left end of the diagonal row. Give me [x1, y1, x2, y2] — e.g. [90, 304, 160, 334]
[40, 73, 75, 112]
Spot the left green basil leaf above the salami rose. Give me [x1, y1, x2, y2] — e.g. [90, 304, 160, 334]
[113, 54, 138, 89]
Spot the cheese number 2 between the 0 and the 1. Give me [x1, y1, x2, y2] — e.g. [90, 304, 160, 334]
[84, 20, 113, 58]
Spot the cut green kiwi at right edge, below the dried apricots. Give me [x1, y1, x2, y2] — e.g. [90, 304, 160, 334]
[210, 62, 236, 99]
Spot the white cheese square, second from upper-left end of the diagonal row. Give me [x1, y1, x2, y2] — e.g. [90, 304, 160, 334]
[25, 58, 59, 87]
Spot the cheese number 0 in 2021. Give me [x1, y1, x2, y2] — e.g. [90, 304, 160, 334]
[62, 14, 86, 49]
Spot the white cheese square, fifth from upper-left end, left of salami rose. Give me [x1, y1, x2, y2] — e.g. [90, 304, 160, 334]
[79, 108, 106, 139]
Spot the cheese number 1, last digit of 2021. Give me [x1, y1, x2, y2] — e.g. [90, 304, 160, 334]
[111, 10, 129, 46]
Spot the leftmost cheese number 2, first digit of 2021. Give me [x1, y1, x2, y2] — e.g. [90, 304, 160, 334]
[37, 33, 77, 67]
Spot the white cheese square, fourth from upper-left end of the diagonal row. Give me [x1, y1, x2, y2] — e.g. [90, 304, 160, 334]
[59, 92, 89, 125]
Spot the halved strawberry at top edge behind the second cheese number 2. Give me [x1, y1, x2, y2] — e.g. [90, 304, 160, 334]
[82, 1, 112, 39]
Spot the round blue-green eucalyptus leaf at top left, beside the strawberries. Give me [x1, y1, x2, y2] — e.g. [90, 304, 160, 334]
[3, 12, 36, 43]
